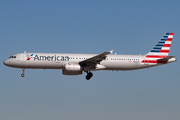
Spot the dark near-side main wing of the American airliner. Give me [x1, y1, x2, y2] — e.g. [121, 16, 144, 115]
[79, 50, 113, 65]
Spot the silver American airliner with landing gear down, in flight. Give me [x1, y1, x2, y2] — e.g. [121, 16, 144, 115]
[3, 33, 176, 80]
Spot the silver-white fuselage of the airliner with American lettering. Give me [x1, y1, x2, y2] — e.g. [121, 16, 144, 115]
[4, 53, 169, 70]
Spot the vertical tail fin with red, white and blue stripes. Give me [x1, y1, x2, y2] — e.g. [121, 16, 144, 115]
[146, 33, 174, 60]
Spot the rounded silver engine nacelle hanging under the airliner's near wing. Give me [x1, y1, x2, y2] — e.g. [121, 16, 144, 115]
[62, 63, 82, 75]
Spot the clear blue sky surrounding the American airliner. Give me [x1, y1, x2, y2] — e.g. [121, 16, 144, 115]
[0, 0, 180, 120]
